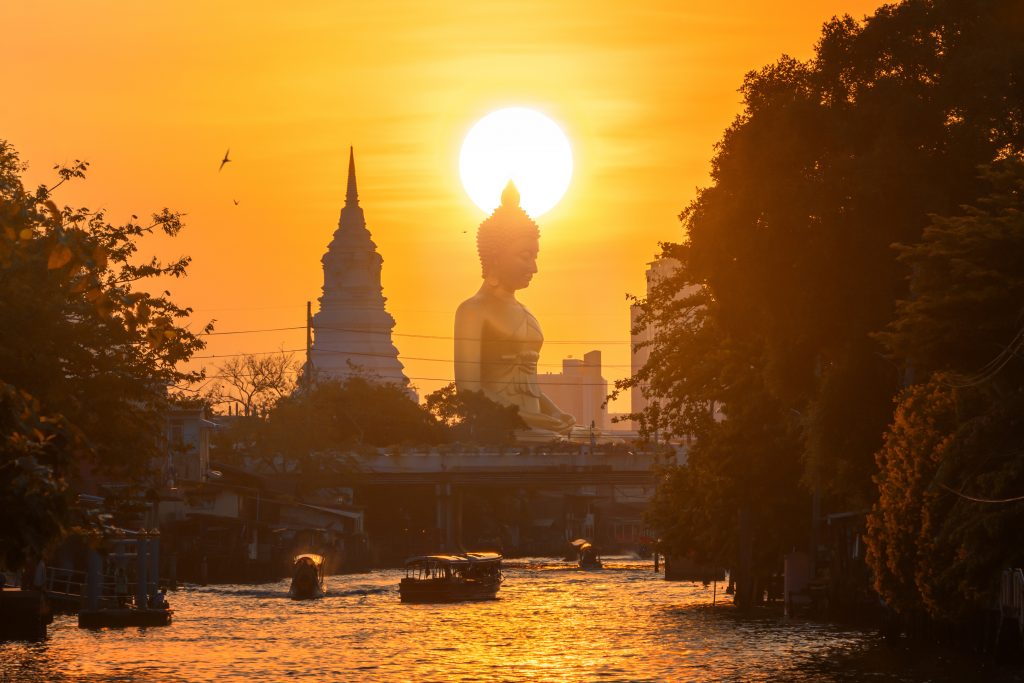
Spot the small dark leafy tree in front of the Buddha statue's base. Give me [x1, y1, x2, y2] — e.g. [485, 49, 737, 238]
[425, 382, 526, 445]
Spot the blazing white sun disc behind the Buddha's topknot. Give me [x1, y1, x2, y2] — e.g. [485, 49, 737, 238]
[459, 106, 572, 218]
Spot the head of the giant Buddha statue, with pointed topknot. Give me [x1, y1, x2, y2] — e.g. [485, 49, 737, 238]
[476, 180, 541, 292]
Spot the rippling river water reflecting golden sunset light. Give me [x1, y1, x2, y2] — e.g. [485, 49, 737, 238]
[0, 558, 1018, 683]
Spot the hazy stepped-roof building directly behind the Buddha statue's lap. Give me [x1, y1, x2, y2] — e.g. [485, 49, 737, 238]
[537, 351, 608, 430]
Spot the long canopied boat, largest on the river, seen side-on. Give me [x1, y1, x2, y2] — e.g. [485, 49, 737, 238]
[398, 553, 505, 602]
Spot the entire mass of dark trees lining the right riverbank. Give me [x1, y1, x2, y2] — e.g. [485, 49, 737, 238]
[616, 0, 1024, 651]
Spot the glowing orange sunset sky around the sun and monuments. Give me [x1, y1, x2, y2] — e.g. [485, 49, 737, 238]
[0, 0, 878, 411]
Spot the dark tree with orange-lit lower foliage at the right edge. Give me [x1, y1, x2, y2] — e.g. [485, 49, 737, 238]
[867, 157, 1024, 620]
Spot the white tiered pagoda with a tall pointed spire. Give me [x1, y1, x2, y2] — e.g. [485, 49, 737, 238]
[310, 147, 409, 389]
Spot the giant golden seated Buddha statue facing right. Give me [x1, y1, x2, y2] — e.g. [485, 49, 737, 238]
[455, 181, 575, 440]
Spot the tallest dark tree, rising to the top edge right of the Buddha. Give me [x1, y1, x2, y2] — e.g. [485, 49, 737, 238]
[617, 0, 1024, 610]
